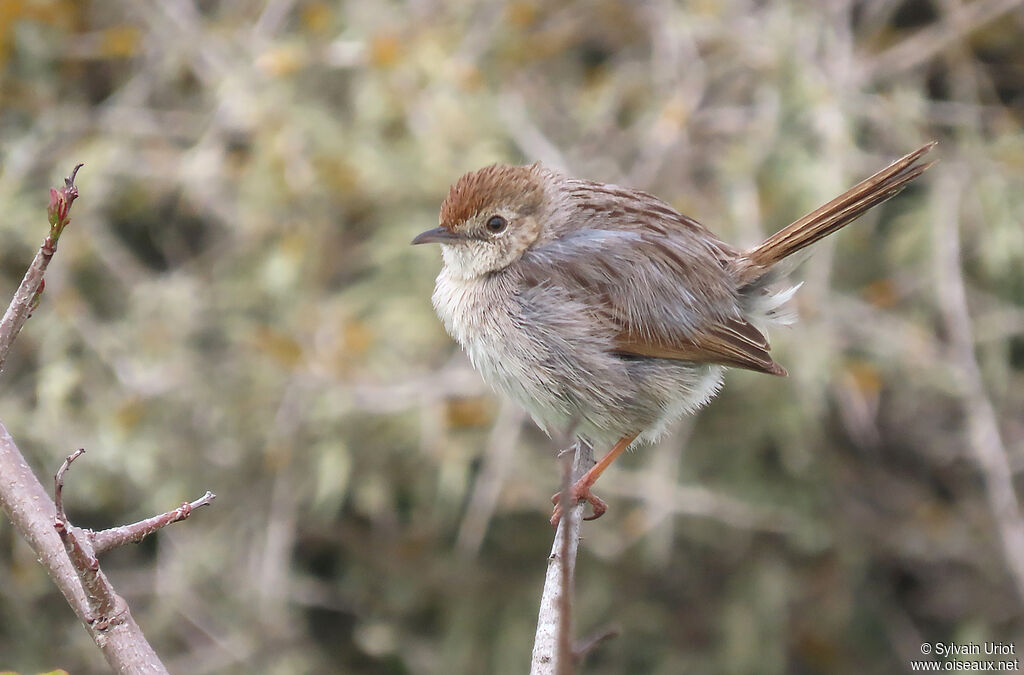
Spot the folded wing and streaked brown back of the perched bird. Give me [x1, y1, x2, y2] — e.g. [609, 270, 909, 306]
[519, 181, 785, 375]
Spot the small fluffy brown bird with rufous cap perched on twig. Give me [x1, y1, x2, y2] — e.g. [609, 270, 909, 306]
[413, 142, 935, 524]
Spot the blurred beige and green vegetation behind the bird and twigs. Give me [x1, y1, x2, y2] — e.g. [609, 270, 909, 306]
[0, 0, 1024, 674]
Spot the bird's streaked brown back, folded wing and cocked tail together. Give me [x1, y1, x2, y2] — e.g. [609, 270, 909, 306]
[520, 143, 935, 376]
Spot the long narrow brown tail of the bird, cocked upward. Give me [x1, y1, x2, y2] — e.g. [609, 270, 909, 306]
[739, 140, 935, 283]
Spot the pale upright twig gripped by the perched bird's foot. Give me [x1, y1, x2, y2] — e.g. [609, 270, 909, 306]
[529, 439, 594, 675]
